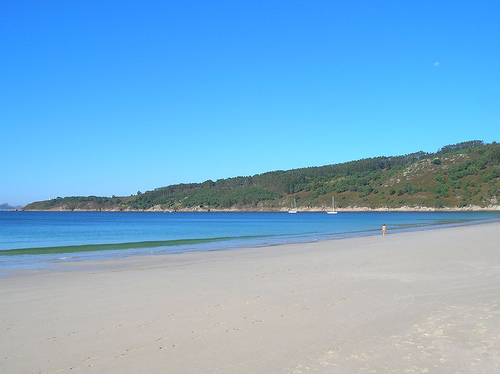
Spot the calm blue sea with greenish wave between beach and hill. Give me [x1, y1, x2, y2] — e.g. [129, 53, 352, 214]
[0, 212, 500, 271]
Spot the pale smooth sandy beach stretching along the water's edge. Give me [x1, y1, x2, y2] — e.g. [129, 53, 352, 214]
[0, 223, 500, 374]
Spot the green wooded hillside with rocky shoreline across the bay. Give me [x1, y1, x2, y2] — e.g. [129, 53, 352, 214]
[24, 140, 500, 211]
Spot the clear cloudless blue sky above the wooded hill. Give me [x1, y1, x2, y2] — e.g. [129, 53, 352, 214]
[0, 0, 500, 205]
